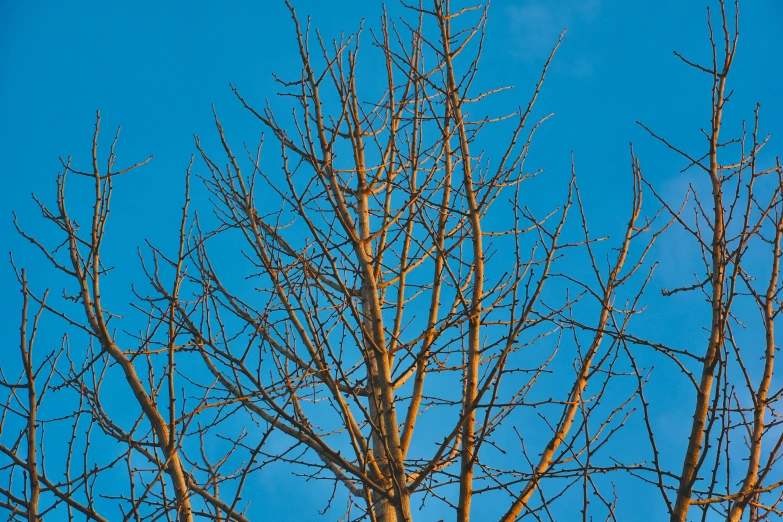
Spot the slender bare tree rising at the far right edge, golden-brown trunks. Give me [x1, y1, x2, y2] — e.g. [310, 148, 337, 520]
[645, 5, 783, 521]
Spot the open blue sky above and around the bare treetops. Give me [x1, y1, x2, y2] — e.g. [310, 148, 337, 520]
[0, 0, 783, 520]
